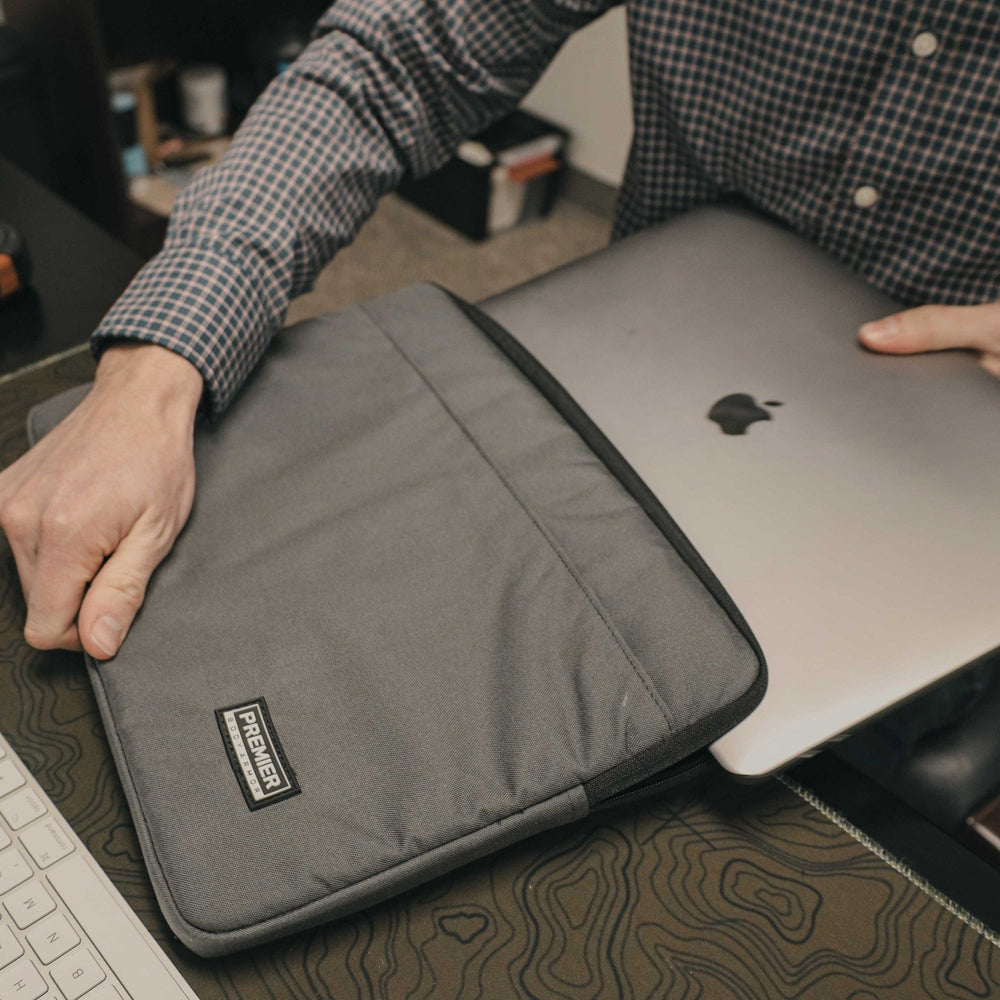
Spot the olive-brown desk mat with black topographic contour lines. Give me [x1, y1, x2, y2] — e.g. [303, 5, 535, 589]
[0, 354, 1000, 1000]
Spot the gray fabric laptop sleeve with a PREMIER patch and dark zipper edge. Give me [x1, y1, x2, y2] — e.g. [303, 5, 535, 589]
[29, 285, 765, 955]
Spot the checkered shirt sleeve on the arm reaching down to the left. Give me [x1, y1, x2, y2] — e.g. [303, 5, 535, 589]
[93, 0, 618, 412]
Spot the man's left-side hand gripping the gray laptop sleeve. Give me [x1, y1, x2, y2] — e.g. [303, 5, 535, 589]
[0, 344, 202, 660]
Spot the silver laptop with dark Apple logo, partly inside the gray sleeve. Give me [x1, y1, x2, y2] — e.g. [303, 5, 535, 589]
[484, 207, 1000, 776]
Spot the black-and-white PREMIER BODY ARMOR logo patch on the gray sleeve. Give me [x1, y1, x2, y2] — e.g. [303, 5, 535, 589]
[215, 698, 302, 809]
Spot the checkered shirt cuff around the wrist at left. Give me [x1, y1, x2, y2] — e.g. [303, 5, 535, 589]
[91, 242, 285, 414]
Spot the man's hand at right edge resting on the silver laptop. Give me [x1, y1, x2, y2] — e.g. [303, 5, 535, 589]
[858, 302, 1000, 378]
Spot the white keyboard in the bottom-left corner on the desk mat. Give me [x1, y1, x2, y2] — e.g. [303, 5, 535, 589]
[0, 736, 198, 1000]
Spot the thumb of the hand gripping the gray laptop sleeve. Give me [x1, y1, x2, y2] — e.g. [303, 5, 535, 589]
[78, 533, 166, 660]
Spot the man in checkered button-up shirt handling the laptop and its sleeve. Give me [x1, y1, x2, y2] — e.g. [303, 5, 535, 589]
[0, 0, 1000, 659]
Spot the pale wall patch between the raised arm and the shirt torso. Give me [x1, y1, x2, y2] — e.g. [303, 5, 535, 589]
[523, 7, 632, 186]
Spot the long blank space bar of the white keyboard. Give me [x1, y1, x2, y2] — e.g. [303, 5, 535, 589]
[49, 854, 194, 1000]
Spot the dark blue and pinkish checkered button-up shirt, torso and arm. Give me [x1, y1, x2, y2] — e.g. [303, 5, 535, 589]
[94, 0, 1000, 411]
